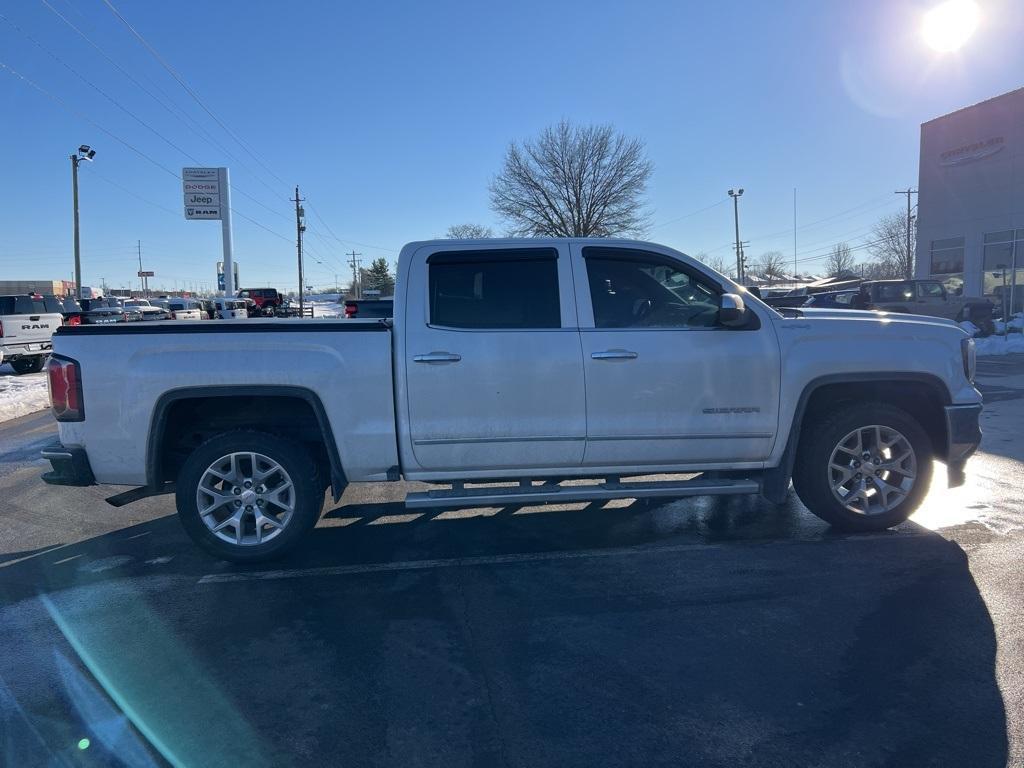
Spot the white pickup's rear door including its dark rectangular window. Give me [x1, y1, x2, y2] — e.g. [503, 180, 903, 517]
[399, 244, 587, 472]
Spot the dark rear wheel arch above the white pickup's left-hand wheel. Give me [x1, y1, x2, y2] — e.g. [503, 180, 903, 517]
[145, 385, 348, 502]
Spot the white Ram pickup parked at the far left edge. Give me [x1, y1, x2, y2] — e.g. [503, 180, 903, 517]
[0, 294, 63, 374]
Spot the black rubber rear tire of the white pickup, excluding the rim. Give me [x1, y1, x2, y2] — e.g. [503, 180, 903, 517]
[175, 430, 324, 562]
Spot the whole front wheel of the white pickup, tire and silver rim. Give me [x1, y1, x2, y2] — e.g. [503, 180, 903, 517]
[793, 402, 932, 531]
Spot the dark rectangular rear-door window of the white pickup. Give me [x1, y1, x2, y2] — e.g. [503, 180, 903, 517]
[427, 248, 562, 330]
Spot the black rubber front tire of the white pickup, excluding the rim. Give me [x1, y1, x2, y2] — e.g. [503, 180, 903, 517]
[793, 401, 932, 532]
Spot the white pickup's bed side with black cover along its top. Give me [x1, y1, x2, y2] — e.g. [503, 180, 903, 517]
[53, 318, 398, 485]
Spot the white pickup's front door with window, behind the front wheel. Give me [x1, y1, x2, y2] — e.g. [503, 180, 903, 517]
[573, 246, 779, 467]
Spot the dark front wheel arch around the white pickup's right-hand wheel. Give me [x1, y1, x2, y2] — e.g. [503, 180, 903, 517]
[762, 372, 952, 503]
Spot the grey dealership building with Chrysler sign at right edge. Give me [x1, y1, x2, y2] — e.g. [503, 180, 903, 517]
[916, 88, 1024, 311]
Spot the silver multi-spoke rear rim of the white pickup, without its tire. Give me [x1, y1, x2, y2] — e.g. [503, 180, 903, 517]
[196, 452, 295, 546]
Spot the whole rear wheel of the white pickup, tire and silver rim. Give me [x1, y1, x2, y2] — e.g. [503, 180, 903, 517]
[176, 430, 324, 562]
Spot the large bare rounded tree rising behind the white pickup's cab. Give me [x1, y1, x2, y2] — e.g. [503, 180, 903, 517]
[490, 120, 651, 238]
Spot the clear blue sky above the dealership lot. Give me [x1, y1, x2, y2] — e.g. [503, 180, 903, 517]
[0, 0, 1024, 288]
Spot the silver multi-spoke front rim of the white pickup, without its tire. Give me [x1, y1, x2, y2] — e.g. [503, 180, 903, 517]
[828, 424, 918, 515]
